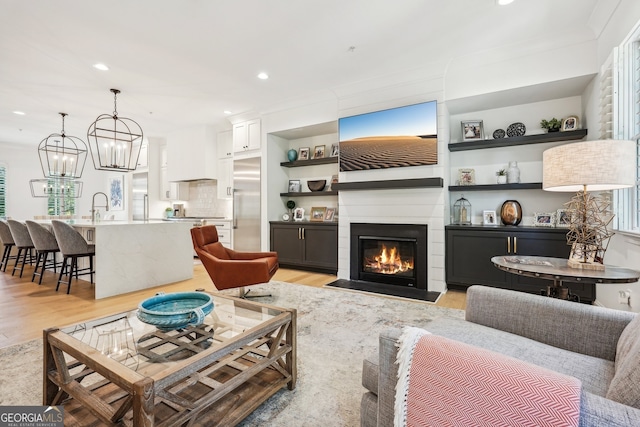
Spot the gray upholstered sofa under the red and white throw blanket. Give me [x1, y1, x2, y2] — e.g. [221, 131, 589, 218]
[360, 286, 640, 427]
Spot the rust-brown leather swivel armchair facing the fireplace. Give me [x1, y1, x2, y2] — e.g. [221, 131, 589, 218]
[191, 225, 278, 296]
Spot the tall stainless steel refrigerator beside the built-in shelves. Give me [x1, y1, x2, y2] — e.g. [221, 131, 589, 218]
[233, 157, 260, 251]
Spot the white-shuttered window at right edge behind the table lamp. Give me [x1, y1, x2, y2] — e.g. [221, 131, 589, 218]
[614, 23, 640, 233]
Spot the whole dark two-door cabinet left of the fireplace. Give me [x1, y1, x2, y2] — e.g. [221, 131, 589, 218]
[270, 221, 338, 274]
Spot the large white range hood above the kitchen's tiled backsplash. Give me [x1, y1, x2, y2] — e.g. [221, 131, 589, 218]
[167, 126, 218, 181]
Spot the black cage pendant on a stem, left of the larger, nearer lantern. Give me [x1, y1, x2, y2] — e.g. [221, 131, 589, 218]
[38, 113, 87, 179]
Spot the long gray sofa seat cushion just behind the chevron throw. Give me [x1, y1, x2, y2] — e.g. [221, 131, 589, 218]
[427, 317, 615, 396]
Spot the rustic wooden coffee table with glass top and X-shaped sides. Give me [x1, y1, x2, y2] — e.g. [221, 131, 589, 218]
[43, 294, 297, 426]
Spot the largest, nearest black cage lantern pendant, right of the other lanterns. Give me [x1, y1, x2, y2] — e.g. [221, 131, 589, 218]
[87, 89, 142, 172]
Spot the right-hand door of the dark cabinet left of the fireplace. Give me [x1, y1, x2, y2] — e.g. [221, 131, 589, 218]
[302, 225, 338, 270]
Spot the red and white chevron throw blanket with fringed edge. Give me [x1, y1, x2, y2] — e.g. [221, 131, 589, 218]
[394, 327, 581, 427]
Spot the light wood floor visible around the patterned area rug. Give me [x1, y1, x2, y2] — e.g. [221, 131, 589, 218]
[0, 261, 466, 348]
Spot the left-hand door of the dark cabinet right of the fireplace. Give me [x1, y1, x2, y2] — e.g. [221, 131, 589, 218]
[446, 230, 509, 288]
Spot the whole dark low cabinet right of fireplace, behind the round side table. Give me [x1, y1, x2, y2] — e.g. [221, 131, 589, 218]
[445, 225, 596, 302]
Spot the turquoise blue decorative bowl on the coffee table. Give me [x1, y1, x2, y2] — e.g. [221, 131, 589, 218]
[136, 292, 213, 331]
